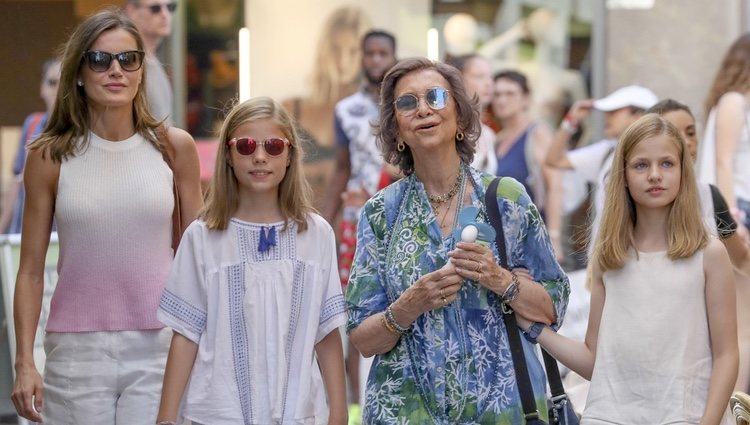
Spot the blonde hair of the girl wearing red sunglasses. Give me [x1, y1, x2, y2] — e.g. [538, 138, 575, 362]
[198, 97, 315, 232]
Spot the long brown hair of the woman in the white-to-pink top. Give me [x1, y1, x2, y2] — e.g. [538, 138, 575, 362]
[29, 9, 164, 162]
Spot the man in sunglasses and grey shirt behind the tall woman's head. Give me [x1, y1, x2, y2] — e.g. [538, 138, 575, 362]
[124, 0, 177, 123]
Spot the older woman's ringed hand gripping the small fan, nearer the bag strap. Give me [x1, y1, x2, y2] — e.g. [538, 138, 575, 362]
[448, 242, 512, 295]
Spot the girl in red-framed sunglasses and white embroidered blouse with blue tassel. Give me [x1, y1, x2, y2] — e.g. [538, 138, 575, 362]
[156, 97, 347, 425]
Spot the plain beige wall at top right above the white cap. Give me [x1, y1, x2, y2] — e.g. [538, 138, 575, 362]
[607, 0, 742, 122]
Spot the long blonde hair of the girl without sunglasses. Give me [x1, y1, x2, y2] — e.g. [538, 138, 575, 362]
[592, 114, 708, 271]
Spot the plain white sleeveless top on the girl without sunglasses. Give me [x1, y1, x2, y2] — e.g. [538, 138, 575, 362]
[581, 250, 726, 424]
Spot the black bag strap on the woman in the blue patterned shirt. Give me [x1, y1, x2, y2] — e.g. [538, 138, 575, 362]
[484, 177, 565, 423]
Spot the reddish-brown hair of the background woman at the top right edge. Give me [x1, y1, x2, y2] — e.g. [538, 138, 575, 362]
[704, 33, 750, 117]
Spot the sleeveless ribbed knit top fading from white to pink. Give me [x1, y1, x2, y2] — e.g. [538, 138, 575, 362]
[47, 133, 174, 332]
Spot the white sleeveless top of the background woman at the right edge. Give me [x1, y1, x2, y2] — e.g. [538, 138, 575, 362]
[696, 104, 750, 200]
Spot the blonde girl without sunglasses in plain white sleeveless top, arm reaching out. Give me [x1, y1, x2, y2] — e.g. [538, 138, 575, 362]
[519, 114, 738, 424]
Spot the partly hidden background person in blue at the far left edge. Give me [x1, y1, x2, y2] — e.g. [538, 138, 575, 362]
[0, 58, 60, 233]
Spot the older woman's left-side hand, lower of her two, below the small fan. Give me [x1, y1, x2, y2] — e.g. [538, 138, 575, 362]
[393, 265, 463, 321]
